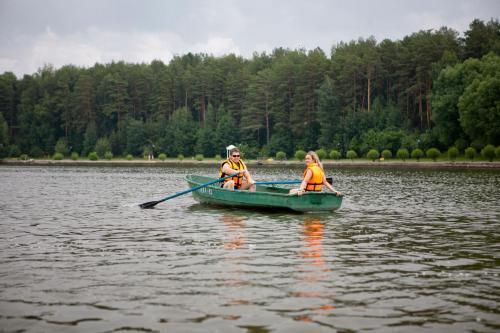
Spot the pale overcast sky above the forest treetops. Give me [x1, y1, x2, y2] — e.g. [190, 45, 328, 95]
[0, 0, 500, 76]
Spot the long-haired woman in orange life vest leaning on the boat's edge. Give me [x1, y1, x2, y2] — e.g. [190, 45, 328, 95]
[290, 151, 341, 196]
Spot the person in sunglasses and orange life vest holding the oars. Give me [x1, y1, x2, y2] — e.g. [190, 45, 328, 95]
[219, 148, 255, 192]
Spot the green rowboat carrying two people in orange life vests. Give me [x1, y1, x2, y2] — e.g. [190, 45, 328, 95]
[186, 175, 342, 212]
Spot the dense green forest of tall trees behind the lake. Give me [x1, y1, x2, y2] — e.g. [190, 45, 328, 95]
[0, 20, 500, 157]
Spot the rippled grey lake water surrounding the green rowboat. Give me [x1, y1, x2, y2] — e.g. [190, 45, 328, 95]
[0, 166, 500, 333]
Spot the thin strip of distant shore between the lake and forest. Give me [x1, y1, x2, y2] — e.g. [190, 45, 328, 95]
[0, 159, 500, 169]
